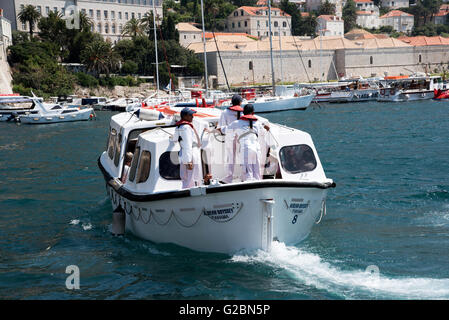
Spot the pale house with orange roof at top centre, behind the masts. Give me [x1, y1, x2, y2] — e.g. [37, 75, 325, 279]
[226, 6, 292, 37]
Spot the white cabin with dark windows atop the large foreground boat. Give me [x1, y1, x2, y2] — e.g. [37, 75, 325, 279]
[101, 109, 326, 193]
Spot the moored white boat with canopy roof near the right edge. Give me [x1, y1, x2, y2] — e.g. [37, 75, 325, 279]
[377, 75, 446, 102]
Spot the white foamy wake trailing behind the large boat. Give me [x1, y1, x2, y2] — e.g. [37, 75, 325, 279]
[232, 242, 449, 299]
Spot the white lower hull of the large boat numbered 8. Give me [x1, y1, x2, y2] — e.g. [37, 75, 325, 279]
[107, 181, 327, 254]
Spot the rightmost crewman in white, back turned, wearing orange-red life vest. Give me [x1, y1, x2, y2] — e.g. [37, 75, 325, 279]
[226, 104, 270, 181]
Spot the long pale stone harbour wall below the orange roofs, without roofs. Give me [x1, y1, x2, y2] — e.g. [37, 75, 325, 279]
[198, 46, 449, 88]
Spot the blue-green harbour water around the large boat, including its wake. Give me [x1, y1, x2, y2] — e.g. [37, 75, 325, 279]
[0, 101, 449, 299]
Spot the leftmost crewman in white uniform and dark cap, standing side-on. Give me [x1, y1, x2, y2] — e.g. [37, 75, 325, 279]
[172, 107, 202, 189]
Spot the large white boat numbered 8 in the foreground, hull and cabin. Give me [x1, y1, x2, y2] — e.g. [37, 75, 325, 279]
[98, 107, 335, 254]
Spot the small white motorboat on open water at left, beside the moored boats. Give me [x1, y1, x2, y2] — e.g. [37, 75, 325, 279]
[18, 97, 94, 124]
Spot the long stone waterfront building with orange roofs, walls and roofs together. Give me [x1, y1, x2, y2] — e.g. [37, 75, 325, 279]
[188, 31, 449, 87]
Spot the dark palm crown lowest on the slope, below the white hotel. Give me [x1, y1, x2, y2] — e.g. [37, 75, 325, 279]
[81, 41, 119, 76]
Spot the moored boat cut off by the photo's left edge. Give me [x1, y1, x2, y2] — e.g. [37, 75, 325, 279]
[0, 95, 39, 121]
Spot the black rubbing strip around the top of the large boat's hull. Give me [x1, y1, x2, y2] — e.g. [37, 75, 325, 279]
[98, 156, 336, 202]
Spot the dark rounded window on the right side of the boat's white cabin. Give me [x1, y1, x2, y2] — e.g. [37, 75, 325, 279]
[279, 144, 317, 174]
